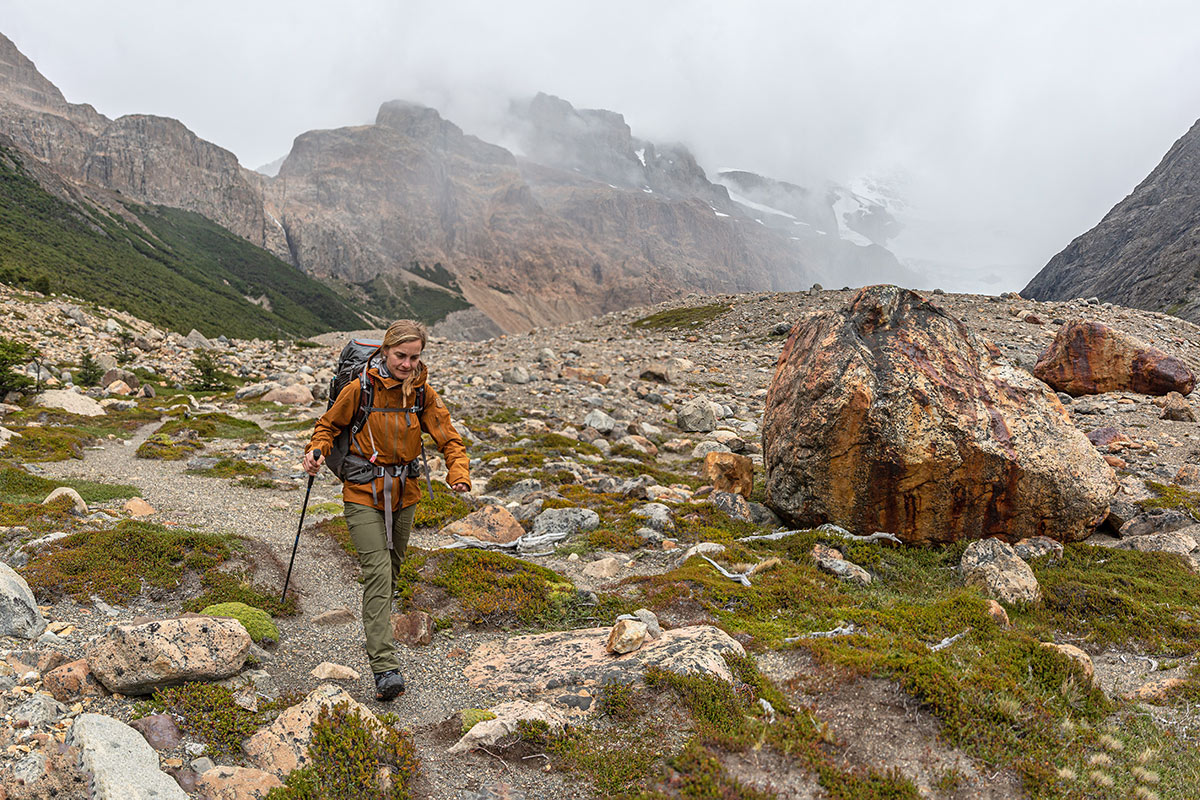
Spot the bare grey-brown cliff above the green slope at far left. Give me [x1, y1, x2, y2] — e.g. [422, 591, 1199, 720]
[0, 35, 269, 246]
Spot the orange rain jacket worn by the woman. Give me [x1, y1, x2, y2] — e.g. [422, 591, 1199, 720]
[305, 363, 470, 511]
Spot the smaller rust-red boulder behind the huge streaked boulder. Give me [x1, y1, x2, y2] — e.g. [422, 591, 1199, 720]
[1033, 319, 1196, 397]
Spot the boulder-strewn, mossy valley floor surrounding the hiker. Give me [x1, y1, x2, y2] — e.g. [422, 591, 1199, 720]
[0, 287, 1200, 800]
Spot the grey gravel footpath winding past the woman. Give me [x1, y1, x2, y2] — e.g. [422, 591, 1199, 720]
[34, 425, 571, 798]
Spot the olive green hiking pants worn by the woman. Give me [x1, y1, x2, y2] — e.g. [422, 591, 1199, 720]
[344, 503, 416, 673]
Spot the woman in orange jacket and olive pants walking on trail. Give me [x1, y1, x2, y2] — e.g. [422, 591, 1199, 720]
[304, 319, 470, 700]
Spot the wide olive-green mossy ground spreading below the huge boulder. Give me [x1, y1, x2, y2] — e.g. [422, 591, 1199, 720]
[626, 531, 1200, 798]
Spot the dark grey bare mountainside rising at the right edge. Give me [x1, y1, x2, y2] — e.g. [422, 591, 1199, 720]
[1021, 121, 1200, 321]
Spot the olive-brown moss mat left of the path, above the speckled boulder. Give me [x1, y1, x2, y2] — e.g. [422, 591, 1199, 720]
[23, 519, 232, 603]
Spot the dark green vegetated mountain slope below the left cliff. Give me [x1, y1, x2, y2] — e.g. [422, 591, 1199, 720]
[0, 144, 366, 338]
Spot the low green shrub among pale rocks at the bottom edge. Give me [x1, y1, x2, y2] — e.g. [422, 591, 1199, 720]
[266, 703, 419, 800]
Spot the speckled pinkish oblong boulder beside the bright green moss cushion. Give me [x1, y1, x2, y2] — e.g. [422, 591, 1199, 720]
[86, 616, 251, 694]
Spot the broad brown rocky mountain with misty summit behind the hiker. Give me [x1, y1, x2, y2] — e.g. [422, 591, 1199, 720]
[268, 102, 810, 331]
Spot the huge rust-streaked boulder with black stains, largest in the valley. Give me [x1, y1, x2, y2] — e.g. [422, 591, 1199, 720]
[763, 287, 1116, 542]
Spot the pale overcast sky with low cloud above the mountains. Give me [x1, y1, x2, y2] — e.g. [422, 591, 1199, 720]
[0, 0, 1200, 291]
